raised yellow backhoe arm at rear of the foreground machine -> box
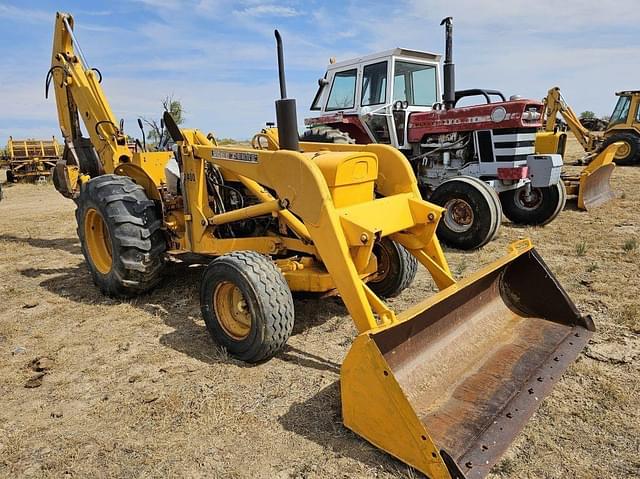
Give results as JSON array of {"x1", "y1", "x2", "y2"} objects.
[{"x1": 47, "y1": 12, "x2": 131, "y2": 173}]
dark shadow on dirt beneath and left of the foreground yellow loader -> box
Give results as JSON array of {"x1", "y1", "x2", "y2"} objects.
[{"x1": 13, "y1": 236, "x2": 347, "y2": 372}]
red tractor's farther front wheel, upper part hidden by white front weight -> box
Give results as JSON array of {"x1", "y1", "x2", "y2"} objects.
[{"x1": 500, "y1": 181, "x2": 567, "y2": 226}]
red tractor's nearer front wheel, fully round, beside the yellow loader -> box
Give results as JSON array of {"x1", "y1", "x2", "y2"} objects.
[{"x1": 429, "y1": 176, "x2": 502, "y2": 250}]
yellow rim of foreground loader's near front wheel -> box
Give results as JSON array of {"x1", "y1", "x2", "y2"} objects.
[{"x1": 218, "y1": 281, "x2": 251, "y2": 340}]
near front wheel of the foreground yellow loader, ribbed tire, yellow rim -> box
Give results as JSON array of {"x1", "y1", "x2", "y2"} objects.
[{"x1": 200, "y1": 251, "x2": 294, "y2": 363}]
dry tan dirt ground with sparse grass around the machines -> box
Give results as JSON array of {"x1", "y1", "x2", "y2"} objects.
[{"x1": 0, "y1": 137, "x2": 640, "y2": 479}]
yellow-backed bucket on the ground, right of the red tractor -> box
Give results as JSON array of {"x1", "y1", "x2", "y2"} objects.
[{"x1": 562, "y1": 143, "x2": 620, "y2": 210}]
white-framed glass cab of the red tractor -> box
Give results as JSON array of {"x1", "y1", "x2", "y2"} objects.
[{"x1": 305, "y1": 48, "x2": 442, "y2": 149}]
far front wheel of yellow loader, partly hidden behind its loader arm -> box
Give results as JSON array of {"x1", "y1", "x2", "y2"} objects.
[{"x1": 367, "y1": 238, "x2": 418, "y2": 298}]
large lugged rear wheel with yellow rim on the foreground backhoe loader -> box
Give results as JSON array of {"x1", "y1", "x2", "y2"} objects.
[{"x1": 76, "y1": 175, "x2": 166, "y2": 298}]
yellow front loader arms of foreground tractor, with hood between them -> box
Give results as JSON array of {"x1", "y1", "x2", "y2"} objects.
[{"x1": 178, "y1": 130, "x2": 455, "y2": 333}]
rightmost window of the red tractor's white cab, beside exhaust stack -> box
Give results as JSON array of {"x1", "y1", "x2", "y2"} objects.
[{"x1": 393, "y1": 61, "x2": 437, "y2": 106}]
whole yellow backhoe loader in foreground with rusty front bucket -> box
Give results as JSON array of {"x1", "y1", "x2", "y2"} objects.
[{"x1": 49, "y1": 13, "x2": 595, "y2": 479}]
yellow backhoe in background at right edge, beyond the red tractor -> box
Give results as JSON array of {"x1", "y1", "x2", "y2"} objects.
[{"x1": 536, "y1": 87, "x2": 628, "y2": 210}]
